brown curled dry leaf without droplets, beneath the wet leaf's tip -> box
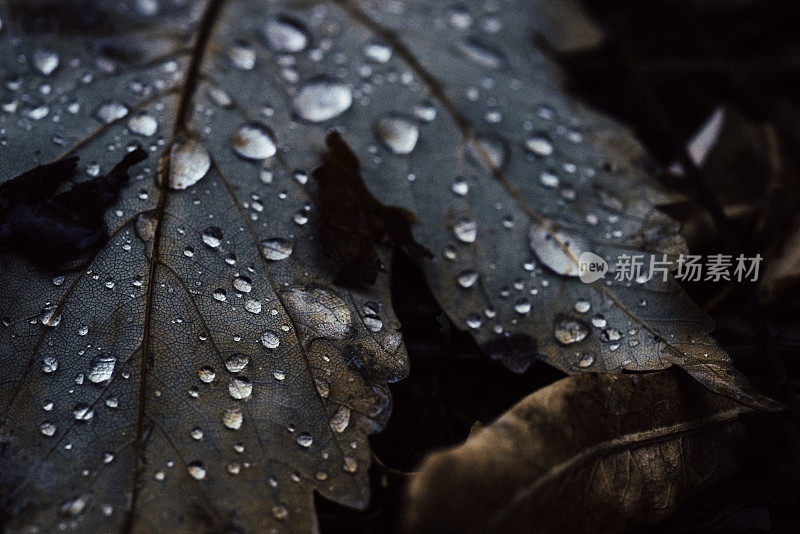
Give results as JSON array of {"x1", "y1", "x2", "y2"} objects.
[{"x1": 406, "y1": 370, "x2": 750, "y2": 533}]
